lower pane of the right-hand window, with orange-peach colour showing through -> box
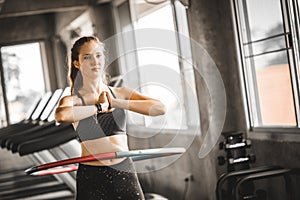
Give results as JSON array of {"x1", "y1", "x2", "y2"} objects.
[{"x1": 254, "y1": 52, "x2": 296, "y2": 126}]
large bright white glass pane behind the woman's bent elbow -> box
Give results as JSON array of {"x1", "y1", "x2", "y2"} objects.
[{"x1": 135, "y1": 2, "x2": 187, "y2": 129}]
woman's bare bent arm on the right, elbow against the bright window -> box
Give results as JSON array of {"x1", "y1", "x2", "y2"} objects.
[{"x1": 108, "y1": 87, "x2": 166, "y2": 116}]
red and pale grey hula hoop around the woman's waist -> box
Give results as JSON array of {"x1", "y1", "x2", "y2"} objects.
[{"x1": 25, "y1": 147, "x2": 185, "y2": 176}]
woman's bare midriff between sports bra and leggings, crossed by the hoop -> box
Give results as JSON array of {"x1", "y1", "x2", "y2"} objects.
[{"x1": 81, "y1": 135, "x2": 128, "y2": 166}]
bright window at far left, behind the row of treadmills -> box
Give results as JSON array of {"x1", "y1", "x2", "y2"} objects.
[{"x1": 0, "y1": 43, "x2": 45, "y2": 126}]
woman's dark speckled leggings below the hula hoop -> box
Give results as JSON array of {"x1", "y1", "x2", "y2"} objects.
[{"x1": 76, "y1": 159, "x2": 145, "y2": 200}]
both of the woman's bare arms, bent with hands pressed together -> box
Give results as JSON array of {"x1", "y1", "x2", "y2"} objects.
[{"x1": 55, "y1": 87, "x2": 166, "y2": 123}]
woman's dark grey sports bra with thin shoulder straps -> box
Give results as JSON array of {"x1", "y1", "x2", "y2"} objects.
[{"x1": 75, "y1": 87, "x2": 126, "y2": 142}]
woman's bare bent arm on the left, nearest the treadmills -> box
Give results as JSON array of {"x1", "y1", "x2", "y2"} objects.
[{"x1": 55, "y1": 96, "x2": 97, "y2": 123}]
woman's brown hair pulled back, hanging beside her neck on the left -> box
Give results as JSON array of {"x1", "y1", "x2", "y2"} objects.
[{"x1": 69, "y1": 36, "x2": 104, "y2": 93}]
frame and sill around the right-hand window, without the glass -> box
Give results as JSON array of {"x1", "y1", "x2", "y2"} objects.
[{"x1": 231, "y1": 0, "x2": 300, "y2": 141}]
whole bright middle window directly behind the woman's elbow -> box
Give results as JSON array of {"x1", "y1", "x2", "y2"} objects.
[{"x1": 115, "y1": 0, "x2": 200, "y2": 130}]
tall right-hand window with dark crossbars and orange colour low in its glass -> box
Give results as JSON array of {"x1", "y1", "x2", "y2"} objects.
[{"x1": 234, "y1": 0, "x2": 300, "y2": 128}]
